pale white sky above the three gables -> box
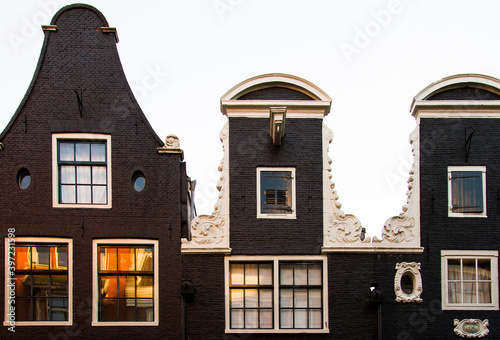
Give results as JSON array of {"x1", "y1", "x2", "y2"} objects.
[{"x1": 0, "y1": 0, "x2": 500, "y2": 236}]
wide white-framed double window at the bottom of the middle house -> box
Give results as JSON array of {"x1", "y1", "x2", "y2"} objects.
[{"x1": 225, "y1": 256, "x2": 328, "y2": 333}]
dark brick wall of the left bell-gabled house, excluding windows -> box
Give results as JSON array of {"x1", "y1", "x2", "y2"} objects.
[{"x1": 0, "y1": 6, "x2": 181, "y2": 339}]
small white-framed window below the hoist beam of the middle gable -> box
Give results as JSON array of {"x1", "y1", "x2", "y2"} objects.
[{"x1": 257, "y1": 168, "x2": 296, "y2": 218}]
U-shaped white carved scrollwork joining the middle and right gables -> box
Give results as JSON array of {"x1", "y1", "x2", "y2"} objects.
[{"x1": 322, "y1": 124, "x2": 423, "y2": 253}]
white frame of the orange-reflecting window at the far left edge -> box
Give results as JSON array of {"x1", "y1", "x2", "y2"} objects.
[{"x1": 3, "y1": 237, "x2": 73, "y2": 326}]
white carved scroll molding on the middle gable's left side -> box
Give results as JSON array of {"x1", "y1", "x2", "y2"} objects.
[{"x1": 181, "y1": 122, "x2": 231, "y2": 254}]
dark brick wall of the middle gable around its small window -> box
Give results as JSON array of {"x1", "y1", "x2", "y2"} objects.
[{"x1": 229, "y1": 118, "x2": 323, "y2": 255}]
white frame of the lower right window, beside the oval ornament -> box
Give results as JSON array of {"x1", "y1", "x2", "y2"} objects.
[{"x1": 441, "y1": 250, "x2": 498, "y2": 310}]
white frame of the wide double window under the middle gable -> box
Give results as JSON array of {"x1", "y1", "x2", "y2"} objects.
[{"x1": 224, "y1": 255, "x2": 330, "y2": 334}]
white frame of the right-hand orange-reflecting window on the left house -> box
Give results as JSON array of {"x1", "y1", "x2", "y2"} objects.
[{"x1": 92, "y1": 239, "x2": 160, "y2": 327}]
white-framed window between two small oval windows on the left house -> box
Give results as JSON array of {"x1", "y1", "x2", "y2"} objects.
[{"x1": 52, "y1": 134, "x2": 111, "y2": 208}]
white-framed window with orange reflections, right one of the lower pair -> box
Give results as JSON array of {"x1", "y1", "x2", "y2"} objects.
[{"x1": 92, "y1": 240, "x2": 159, "y2": 326}]
